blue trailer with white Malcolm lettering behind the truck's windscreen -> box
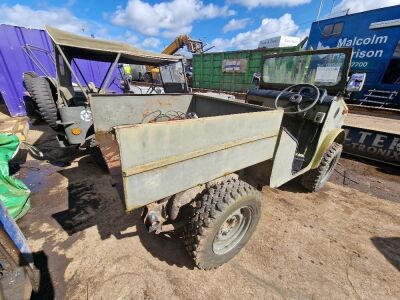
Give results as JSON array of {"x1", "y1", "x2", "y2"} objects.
[{"x1": 307, "y1": 5, "x2": 400, "y2": 105}]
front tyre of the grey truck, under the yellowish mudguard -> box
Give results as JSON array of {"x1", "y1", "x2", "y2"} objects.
[{"x1": 301, "y1": 142, "x2": 343, "y2": 192}]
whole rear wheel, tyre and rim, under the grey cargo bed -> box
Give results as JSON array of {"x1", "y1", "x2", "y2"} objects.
[{"x1": 184, "y1": 179, "x2": 261, "y2": 270}]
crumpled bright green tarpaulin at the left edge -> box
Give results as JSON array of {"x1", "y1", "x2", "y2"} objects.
[{"x1": 0, "y1": 133, "x2": 30, "y2": 220}]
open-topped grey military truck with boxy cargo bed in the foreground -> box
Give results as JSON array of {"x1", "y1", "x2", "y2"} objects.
[{"x1": 89, "y1": 48, "x2": 352, "y2": 269}]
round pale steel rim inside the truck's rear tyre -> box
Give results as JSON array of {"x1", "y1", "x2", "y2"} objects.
[{"x1": 213, "y1": 206, "x2": 253, "y2": 255}]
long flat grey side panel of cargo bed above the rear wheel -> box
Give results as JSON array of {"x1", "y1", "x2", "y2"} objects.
[{"x1": 115, "y1": 111, "x2": 282, "y2": 210}]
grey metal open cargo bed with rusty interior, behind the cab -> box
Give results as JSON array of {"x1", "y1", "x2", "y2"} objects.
[{"x1": 91, "y1": 94, "x2": 283, "y2": 210}]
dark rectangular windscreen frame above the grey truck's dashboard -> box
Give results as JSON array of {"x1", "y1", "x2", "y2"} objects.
[{"x1": 260, "y1": 48, "x2": 353, "y2": 94}]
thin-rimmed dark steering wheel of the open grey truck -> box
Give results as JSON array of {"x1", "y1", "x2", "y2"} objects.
[{"x1": 275, "y1": 83, "x2": 320, "y2": 115}]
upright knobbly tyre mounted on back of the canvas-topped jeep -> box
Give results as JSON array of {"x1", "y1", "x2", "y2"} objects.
[{"x1": 31, "y1": 77, "x2": 58, "y2": 130}]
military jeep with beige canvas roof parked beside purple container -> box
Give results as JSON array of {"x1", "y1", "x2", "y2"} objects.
[{"x1": 25, "y1": 27, "x2": 188, "y2": 147}]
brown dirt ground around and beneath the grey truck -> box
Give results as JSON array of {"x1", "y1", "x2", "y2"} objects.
[{"x1": 12, "y1": 125, "x2": 400, "y2": 299}]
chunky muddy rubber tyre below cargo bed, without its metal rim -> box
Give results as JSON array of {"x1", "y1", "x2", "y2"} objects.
[{"x1": 184, "y1": 178, "x2": 261, "y2": 270}]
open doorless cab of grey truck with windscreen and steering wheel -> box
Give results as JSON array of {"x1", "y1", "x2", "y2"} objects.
[{"x1": 246, "y1": 48, "x2": 352, "y2": 189}]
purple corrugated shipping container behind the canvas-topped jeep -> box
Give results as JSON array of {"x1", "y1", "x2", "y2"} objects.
[{"x1": 0, "y1": 24, "x2": 122, "y2": 117}]
